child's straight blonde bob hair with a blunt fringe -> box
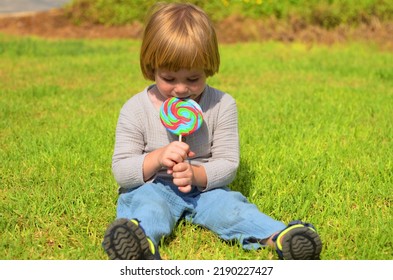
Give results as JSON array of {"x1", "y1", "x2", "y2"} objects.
[{"x1": 140, "y1": 3, "x2": 220, "y2": 81}]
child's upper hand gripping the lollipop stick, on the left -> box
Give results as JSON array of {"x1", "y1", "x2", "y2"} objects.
[{"x1": 158, "y1": 141, "x2": 195, "y2": 171}]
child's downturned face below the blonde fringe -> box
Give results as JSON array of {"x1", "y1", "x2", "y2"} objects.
[{"x1": 154, "y1": 69, "x2": 206, "y2": 100}]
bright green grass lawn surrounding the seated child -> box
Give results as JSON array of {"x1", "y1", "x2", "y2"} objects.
[{"x1": 0, "y1": 35, "x2": 393, "y2": 259}]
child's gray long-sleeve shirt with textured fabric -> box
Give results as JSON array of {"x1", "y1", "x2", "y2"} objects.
[{"x1": 112, "y1": 86, "x2": 239, "y2": 190}]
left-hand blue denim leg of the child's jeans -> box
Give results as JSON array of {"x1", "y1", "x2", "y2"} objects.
[{"x1": 117, "y1": 182, "x2": 187, "y2": 245}]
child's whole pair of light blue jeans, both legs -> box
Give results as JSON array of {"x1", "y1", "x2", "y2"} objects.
[{"x1": 117, "y1": 180, "x2": 285, "y2": 249}]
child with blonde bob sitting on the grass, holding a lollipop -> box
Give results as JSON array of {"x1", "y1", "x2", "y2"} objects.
[{"x1": 103, "y1": 4, "x2": 322, "y2": 259}]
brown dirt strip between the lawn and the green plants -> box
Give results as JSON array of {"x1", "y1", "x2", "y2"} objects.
[{"x1": 0, "y1": 9, "x2": 393, "y2": 51}]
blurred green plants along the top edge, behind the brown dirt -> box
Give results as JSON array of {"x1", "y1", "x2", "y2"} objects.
[{"x1": 68, "y1": 0, "x2": 393, "y2": 28}]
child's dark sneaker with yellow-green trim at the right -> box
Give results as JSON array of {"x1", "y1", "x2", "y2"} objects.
[{"x1": 273, "y1": 221, "x2": 322, "y2": 260}]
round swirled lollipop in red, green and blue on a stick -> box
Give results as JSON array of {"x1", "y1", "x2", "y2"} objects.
[{"x1": 160, "y1": 97, "x2": 203, "y2": 141}]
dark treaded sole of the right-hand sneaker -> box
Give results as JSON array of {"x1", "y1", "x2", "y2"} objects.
[{"x1": 282, "y1": 227, "x2": 322, "y2": 260}]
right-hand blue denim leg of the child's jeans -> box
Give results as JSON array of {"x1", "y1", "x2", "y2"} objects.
[{"x1": 192, "y1": 188, "x2": 286, "y2": 249}]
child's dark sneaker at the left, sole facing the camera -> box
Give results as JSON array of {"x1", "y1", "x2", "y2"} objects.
[{"x1": 102, "y1": 219, "x2": 161, "y2": 260}]
